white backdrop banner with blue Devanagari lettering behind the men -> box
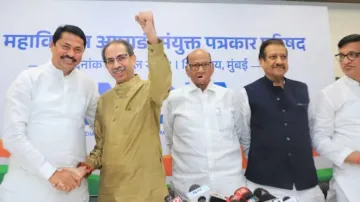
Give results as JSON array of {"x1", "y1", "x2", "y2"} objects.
[{"x1": 0, "y1": 1, "x2": 335, "y2": 188}]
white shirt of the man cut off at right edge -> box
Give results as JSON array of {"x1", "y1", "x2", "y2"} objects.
[{"x1": 312, "y1": 76, "x2": 360, "y2": 201}]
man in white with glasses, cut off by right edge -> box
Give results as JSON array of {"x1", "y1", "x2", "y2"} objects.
[{"x1": 313, "y1": 35, "x2": 360, "y2": 202}]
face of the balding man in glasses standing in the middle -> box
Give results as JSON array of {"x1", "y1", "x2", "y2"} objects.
[{"x1": 186, "y1": 49, "x2": 214, "y2": 90}]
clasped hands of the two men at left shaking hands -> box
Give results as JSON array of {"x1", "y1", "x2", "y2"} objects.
[{"x1": 49, "y1": 165, "x2": 92, "y2": 192}]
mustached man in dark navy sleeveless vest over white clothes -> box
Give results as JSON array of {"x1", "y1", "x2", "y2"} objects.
[{"x1": 241, "y1": 39, "x2": 325, "y2": 202}]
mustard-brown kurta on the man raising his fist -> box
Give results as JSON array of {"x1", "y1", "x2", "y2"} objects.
[{"x1": 87, "y1": 43, "x2": 172, "y2": 202}]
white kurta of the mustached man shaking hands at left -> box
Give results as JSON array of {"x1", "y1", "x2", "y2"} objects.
[{"x1": 0, "y1": 62, "x2": 98, "y2": 202}]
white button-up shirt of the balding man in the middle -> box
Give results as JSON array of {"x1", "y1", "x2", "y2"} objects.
[{"x1": 163, "y1": 83, "x2": 250, "y2": 196}]
